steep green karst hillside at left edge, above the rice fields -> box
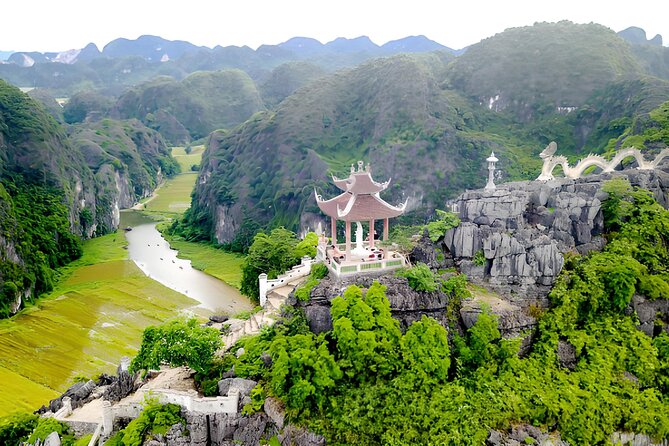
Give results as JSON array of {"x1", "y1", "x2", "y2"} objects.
[{"x1": 0, "y1": 81, "x2": 178, "y2": 317}]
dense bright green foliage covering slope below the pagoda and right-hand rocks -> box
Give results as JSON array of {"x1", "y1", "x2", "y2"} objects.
[{"x1": 196, "y1": 182, "x2": 669, "y2": 445}]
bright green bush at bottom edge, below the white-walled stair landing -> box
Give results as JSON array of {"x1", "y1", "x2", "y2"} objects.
[{"x1": 105, "y1": 400, "x2": 186, "y2": 446}]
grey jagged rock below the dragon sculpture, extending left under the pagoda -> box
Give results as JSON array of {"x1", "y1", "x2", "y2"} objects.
[{"x1": 290, "y1": 170, "x2": 669, "y2": 345}]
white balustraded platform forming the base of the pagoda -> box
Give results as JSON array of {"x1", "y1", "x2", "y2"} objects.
[{"x1": 316, "y1": 242, "x2": 406, "y2": 277}]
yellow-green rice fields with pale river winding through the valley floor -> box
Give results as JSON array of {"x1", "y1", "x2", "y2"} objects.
[{"x1": 0, "y1": 148, "x2": 251, "y2": 416}]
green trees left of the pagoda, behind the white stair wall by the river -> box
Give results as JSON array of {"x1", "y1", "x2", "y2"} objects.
[{"x1": 240, "y1": 228, "x2": 318, "y2": 301}]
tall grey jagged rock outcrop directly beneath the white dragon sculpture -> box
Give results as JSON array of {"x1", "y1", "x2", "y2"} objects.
[{"x1": 443, "y1": 170, "x2": 669, "y2": 307}]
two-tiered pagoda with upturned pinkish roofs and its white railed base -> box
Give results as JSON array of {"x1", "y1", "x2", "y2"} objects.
[{"x1": 314, "y1": 161, "x2": 406, "y2": 275}]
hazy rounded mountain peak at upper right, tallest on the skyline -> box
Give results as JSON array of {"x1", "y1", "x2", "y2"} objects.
[{"x1": 449, "y1": 21, "x2": 642, "y2": 121}]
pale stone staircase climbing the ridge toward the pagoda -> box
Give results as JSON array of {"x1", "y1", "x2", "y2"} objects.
[{"x1": 223, "y1": 277, "x2": 304, "y2": 351}]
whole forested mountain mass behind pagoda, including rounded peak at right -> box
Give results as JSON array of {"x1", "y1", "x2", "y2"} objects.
[{"x1": 179, "y1": 22, "x2": 669, "y2": 246}]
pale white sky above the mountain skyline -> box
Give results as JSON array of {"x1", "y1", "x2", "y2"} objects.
[{"x1": 0, "y1": 0, "x2": 669, "y2": 52}]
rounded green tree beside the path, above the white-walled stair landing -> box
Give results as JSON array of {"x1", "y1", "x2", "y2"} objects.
[{"x1": 130, "y1": 319, "x2": 222, "y2": 373}]
